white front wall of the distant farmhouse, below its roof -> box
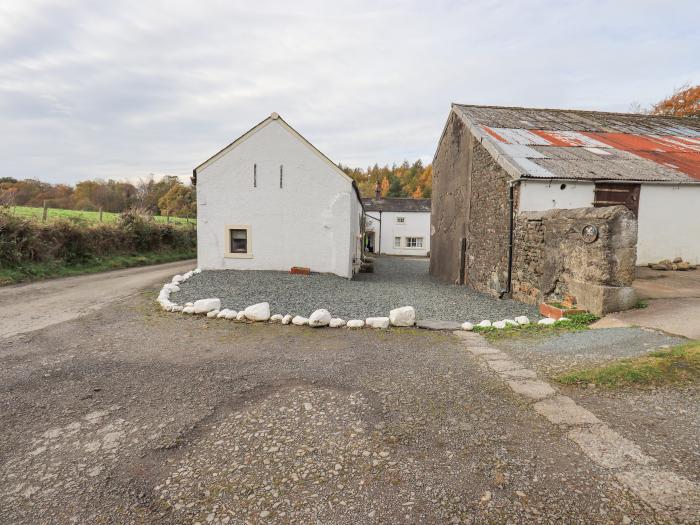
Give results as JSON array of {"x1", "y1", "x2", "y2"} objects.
[{"x1": 366, "y1": 211, "x2": 430, "y2": 257}]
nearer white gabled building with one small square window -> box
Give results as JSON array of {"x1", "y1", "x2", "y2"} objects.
[{"x1": 194, "y1": 113, "x2": 363, "y2": 278}]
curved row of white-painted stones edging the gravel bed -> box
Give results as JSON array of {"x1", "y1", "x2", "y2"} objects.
[{"x1": 158, "y1": 268, "x2": 548, "y2": 331}]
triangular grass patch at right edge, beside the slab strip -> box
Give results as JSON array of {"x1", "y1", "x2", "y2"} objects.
[{"x1": 554, "y1": 341, "x2": 700, "y2": 388}]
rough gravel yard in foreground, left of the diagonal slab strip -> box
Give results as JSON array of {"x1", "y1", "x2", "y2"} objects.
[{"x1": 0, "y1": 294, "x2": 657, "y2": 524}]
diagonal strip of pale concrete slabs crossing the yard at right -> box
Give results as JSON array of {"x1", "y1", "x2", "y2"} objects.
[{"x1": 454, "y1": 331, "x2": 700, "y2": 522}]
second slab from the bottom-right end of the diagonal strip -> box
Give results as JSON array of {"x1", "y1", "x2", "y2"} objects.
[{"x1": 568, "y1": 425, "x2": 656, "y2": 469}]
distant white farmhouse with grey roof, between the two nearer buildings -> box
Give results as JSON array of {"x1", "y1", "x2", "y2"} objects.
[{"x1": 362, "y1": 192, "x2": 430, "y2": 257}]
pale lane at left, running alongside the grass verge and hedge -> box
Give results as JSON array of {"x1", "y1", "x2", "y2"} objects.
[{"x1": 0, "y1": 259, "x2": 196, "y2": 339}]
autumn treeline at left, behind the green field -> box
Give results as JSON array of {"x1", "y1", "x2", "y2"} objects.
[{"x1": 0, "y1": 176, "x2": 197, "y2": 217}]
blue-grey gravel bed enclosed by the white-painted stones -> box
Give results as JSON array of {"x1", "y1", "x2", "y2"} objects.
[{"x1": 172, "y1": 257, "x2": 539, "y2": 322}]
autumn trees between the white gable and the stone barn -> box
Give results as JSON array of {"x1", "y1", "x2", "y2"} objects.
[{"x1": 339, "y1": 160, "x2": 433, "y2": 199}]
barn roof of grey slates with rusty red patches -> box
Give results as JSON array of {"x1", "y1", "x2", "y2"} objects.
[{"x1": 452, "y1": 104, "x2": 700, "y2": 184}]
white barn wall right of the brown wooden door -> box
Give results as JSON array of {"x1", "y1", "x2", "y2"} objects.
[{"x1": 637, "y1": 184, "x2": 700, "y2": 264}]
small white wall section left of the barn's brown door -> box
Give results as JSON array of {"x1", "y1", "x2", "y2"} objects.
[{"x1": 518, "y1": 180, "x2": 595, "y2": 211}]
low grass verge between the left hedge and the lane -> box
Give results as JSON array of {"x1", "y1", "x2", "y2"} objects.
[{"x1": 0, "y1": 250, "x2": 197, "y2": 286}]
